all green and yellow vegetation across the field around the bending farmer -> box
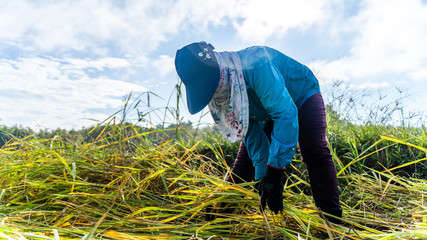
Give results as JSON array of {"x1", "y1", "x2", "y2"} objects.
[{"x1": 0, "y1": 86, "x2": 427, "y2": 240}]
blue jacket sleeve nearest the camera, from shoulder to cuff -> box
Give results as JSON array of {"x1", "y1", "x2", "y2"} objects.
[{"x1": 247, "y1": 61, "x2": 299, "y2": 176}]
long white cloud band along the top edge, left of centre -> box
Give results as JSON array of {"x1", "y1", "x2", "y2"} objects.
[{"x1": 0, "y1": 0, "x2": 237, "y2": 56}]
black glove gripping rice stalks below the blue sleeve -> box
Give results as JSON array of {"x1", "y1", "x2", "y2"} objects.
[{"x1": 258, "y1": 166, "x2": 284, "y2": 213}]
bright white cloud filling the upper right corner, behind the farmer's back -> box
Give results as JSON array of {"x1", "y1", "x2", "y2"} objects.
[{"x1": 311, "y1": 0, "x2": 427, "y2": 81}]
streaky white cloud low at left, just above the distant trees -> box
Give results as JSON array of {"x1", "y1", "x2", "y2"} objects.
[{"x1": 0, "y1": 58, "x2": 147, "y2": 128}]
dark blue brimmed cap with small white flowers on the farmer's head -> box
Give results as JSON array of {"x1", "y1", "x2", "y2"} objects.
[{"x1": 175, "y1": 42, "x2": 220, "y2": 114}]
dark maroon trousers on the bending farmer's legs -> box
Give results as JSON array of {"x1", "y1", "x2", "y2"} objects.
[{"x1": 227, "y1": 93, "x2": 342, "y2": 217}]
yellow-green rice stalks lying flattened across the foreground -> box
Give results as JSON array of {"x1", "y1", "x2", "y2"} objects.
[{"x1": 0, "y1": 118, "x2": 427, "y2": 240}]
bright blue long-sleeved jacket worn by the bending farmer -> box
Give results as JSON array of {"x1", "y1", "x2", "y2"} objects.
[{"x1": 237, "y1": 46, "x2": 320, "y2": 180}]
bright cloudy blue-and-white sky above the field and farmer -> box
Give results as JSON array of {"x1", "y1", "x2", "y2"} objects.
[{"x1": 0, "y1": 0, "x2": 427, "y2": 129}]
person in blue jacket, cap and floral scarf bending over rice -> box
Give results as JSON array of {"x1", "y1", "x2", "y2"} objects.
[{"x1": 175, "y1": 42, "x2": 342, "y2": 222}]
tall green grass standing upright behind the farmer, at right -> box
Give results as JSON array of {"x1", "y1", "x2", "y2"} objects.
[{"x1": 325, "y1": 82, "x2": 427, "y2": 179}]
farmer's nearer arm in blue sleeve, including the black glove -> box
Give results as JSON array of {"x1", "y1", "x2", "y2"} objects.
[{"x1": 252, "y1": 58, "x2": 299, "y2": 213}]
